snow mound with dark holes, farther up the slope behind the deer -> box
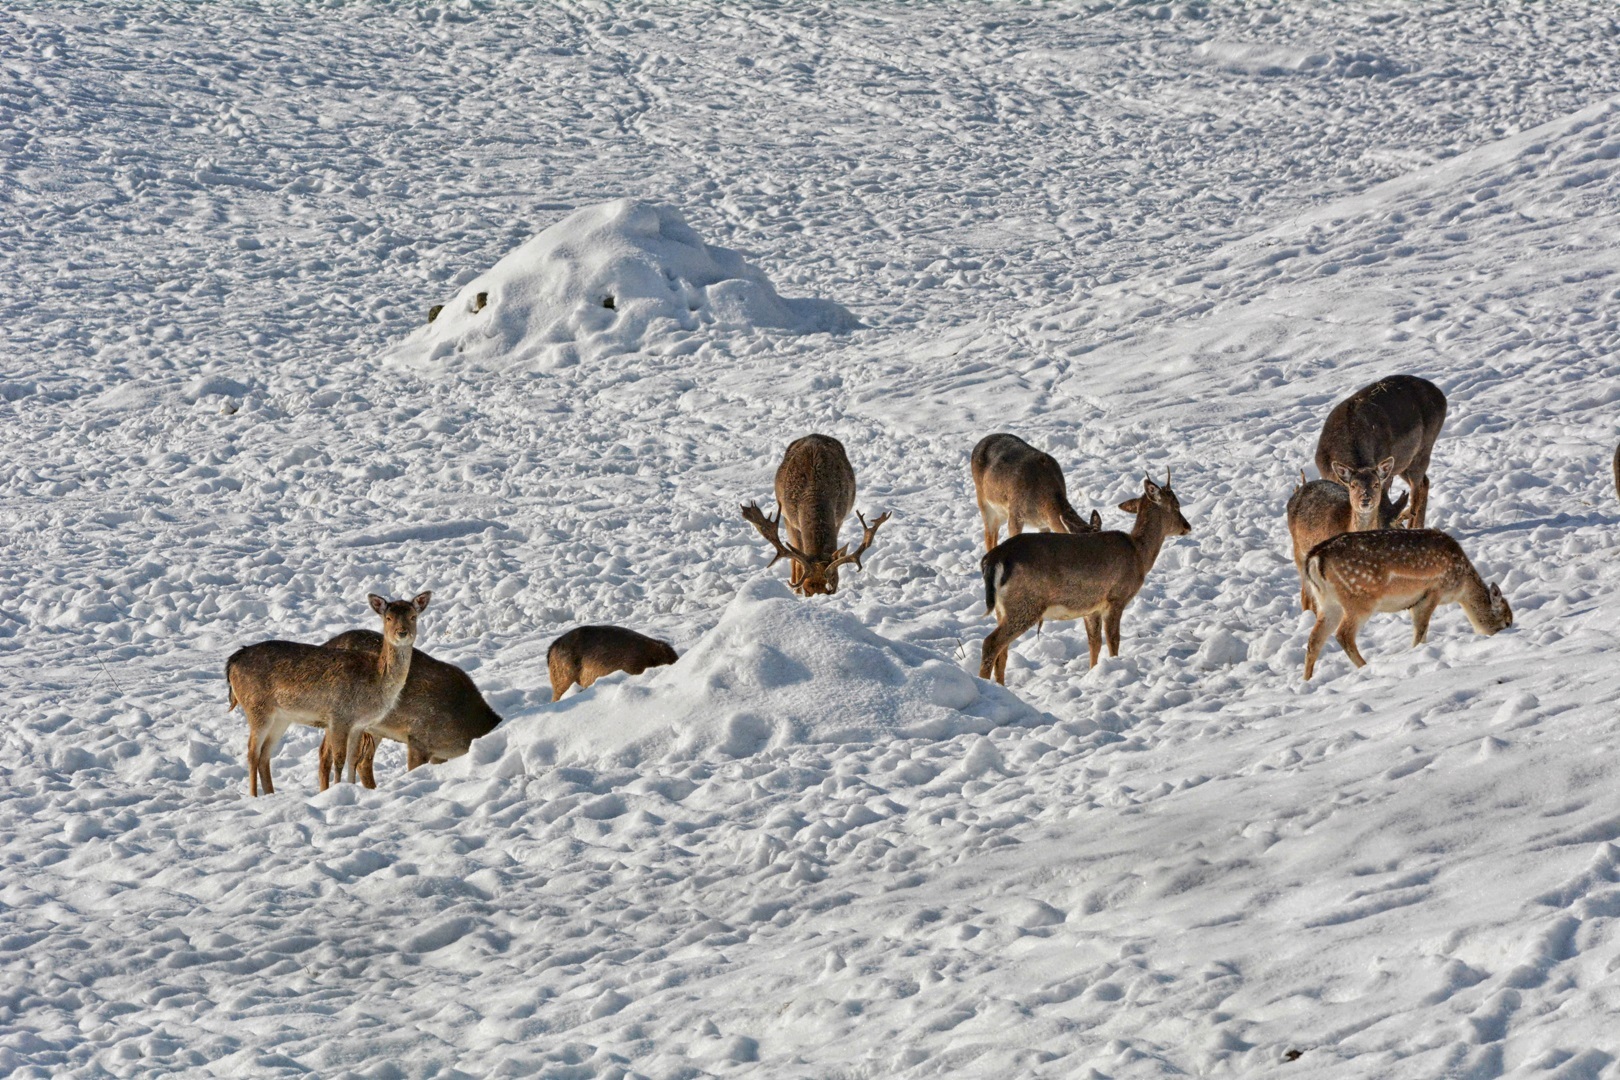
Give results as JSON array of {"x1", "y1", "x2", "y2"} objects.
[{"x1": 389, "y1": 199, "x2": 860, "y2": 368}]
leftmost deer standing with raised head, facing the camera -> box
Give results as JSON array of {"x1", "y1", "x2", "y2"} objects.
[{"x1": 225, "y1": 593, "x2": 433, "y2": 795}]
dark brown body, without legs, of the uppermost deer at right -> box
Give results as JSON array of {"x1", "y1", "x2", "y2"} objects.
[{"x1": 1315, "y1": 376, "x2": 1445, "y2": 479}]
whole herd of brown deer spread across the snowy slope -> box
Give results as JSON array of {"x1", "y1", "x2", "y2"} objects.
[{"x1": 225, "y1": 376, "x2": 1516, "y2": 795}]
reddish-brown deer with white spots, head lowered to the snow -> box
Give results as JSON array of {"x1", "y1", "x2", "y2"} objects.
[{"x1": 1306, "y1": 529, "x2": 1513, "y2": 678}]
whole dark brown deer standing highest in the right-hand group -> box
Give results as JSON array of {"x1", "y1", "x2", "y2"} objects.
[{"x1": 1317, "y1": 376, "x2": 1445, "y2": 533}]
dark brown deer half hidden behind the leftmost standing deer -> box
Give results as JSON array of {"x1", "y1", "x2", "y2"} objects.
[{"x1": 321, "y1": 630, "x2": 501, "y2": 790}]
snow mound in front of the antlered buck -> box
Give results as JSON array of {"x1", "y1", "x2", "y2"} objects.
[{"x1": 447, "y1": 578, "x2": 1053, "y2": 776}]
